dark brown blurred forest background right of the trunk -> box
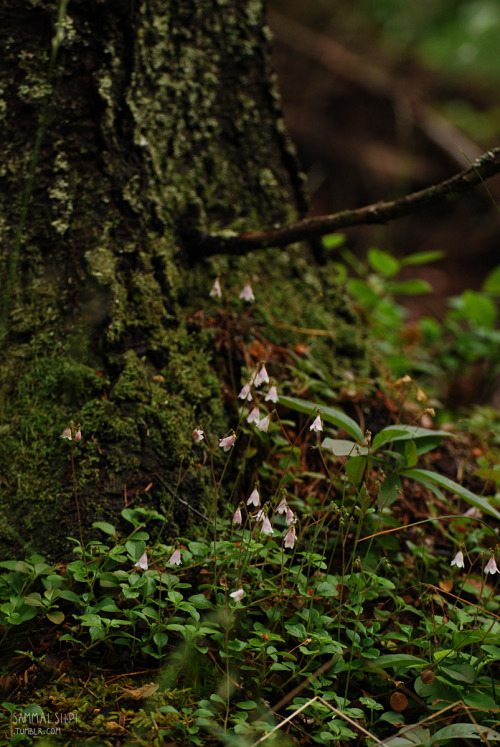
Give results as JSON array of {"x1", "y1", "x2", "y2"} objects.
[{"x1": 268, "y1": 0, "x2": 500, "y2": 315}]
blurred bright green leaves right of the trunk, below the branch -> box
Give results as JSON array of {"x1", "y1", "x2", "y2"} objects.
[{"x1": 330, "y1": 238, "x2": 500, "y2": 404}]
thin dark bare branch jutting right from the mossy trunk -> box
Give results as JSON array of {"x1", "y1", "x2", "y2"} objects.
[{"x1": 184, "y1": 148, "x2": 500, "y2": 259}]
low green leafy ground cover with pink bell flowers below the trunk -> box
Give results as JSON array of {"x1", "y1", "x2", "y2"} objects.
[{"x1": 0, "y1": 386, "x2": 500, "y2": 745}]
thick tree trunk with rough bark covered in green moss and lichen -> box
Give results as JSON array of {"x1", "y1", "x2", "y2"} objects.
[{"x1": 0, "y1": 0, "x2": 367, "y2": 557}]
